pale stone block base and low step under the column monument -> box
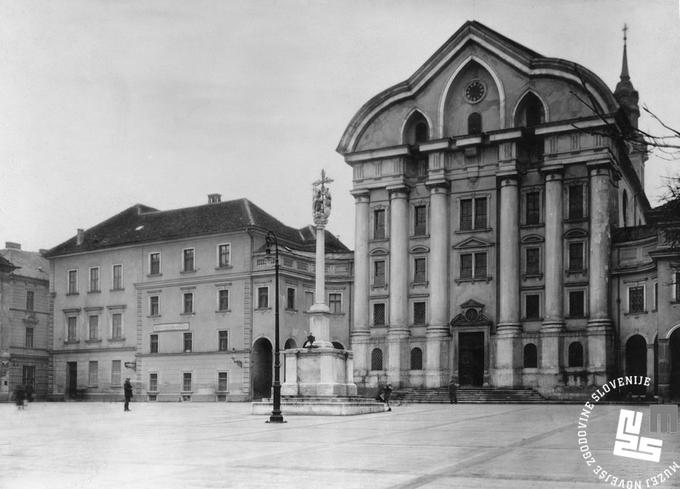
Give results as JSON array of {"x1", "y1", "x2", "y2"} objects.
[{"x1": 252, "y1": 347, "x2": 385, "y2": 416}]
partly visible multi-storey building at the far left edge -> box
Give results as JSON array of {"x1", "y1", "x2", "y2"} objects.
[{"x1": 0, "y1": 242, "x2": 50, "y2": 400}]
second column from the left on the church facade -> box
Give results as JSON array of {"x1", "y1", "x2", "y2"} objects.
[{"x1": 387, "y1": 187, "x2": 410, "y2": 387}]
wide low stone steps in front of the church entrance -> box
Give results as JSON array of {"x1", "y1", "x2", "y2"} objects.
[{"x1": 392, "y1": 387, "x2": 546, "y2": 404}]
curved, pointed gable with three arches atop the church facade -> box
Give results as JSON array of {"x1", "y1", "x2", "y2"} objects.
[{"x1": 337, "y1": 21, "x2": 617, "y2": 154}]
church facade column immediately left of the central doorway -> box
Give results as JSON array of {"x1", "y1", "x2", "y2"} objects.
[{"x1": 425, "y1": 182, "x2": 449, "y2": 387}]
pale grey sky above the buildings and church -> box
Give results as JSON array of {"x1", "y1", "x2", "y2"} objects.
[{"x1": 0, "y1": 0, "x2": 680, "y2": 250}]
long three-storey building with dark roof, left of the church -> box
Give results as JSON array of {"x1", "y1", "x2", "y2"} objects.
[{"x1": 46, "y1": 194, "x2": 352, "y2": 401}]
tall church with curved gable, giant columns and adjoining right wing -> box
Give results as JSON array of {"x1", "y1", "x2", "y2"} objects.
[{"x1": 337, "y1": 21, "x2": 680, "y2": 399}]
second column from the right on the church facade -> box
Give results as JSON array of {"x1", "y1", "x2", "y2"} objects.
[{"x1": 539, "y1": 168, "x2": 564, "y2": 390}]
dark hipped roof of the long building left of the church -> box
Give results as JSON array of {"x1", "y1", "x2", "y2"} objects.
[{"x1": 45, "y1": 199, "x2": 350, "y2": 258}]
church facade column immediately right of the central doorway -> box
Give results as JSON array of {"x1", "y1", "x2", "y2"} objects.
[{"x1": 494, "y1": 175, "x2": 521, "y2": 386}]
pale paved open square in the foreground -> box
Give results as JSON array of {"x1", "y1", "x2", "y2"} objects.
[{"x1": 0, "y1": 402, "x2": 680, "y2": 489}]
